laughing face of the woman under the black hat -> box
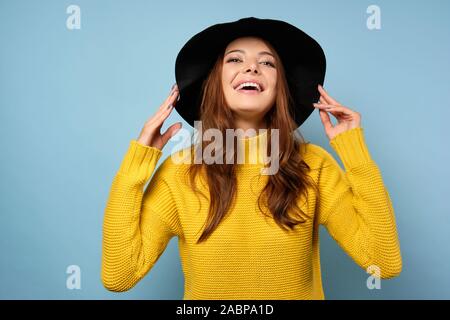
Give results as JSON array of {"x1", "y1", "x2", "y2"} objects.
[{"x1": 222, "y1": 37, "x2": 277, "y2": 124}]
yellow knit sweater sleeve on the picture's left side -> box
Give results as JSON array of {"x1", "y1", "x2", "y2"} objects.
[{"x1": 101, "y1": 140, "x2": 179, "y2": 292}]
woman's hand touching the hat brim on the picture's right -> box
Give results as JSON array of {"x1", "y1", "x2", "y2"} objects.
[{"x1": 313, "y1": 84, "x2": 361, "y2": 140}]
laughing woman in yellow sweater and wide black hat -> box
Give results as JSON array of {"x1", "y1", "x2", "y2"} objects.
[{"x1": 102, "y1": 18, "x2": 402, "y2": 299}]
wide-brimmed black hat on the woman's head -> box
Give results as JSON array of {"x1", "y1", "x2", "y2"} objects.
[{"x1": 175, "y1": 17, "x2": 326, "y2": 126}]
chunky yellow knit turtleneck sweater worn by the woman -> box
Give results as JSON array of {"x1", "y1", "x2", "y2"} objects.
[{"x1": 101, "y1": 128, "x2": 402, "y2": 300}]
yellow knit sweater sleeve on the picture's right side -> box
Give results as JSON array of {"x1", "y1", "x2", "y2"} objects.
[{"x1": 318, "y1": 127, "x2": 402, "y2": 279}]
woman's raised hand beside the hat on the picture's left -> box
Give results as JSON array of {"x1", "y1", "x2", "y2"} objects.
[{"x1": 137, "y1": 84, "x2": 181, "y2": 150}]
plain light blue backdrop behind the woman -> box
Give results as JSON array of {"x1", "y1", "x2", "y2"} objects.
[{"x1": 0, "y1": 0, "x2": 450, "y2": 299}]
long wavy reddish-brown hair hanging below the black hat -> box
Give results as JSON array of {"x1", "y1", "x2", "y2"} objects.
[{"x1": 189, "y1": 39, "x2": 318, "y2": 243}]
